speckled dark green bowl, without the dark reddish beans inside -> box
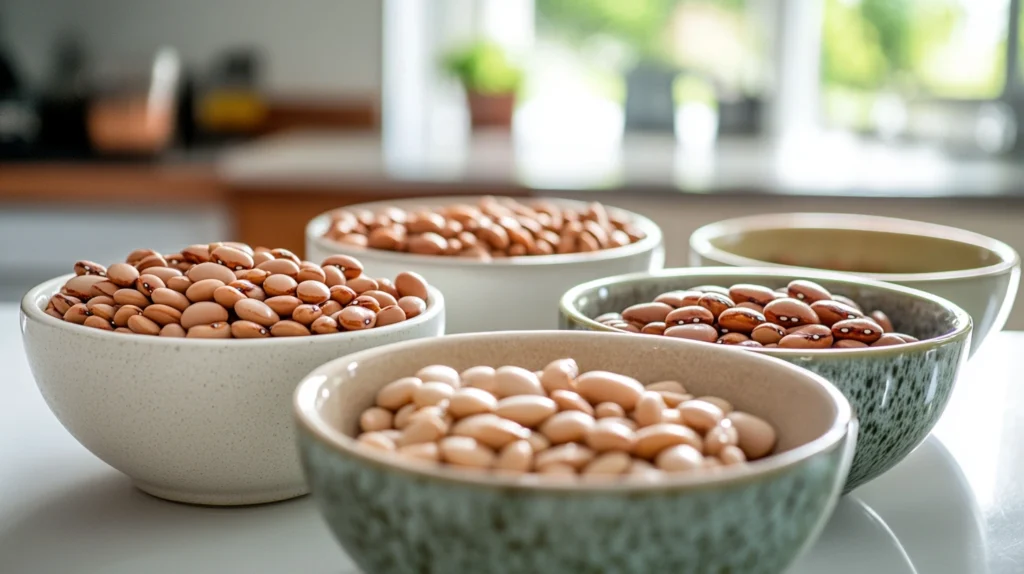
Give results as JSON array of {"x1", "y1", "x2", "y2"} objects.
[{"x1": 561, "y1": 267, "x2": 971, "y2": 492}]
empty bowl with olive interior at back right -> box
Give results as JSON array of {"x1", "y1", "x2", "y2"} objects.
[{"x1": 690, "y1": 213, "x2": 1020, "y2": 355}]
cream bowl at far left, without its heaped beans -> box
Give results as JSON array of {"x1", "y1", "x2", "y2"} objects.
[{"x1": 20, "y1": 275, "x2": 444, "y2": 505}]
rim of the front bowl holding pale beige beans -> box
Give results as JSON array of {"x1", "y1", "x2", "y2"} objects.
[{"x1": 292, "y1": 330, "x2": 858, "y2": 494}]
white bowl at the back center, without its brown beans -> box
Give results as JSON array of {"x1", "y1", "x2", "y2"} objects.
[{"x1": 306, "y1": 196, "x2": 665, "y2": 334}]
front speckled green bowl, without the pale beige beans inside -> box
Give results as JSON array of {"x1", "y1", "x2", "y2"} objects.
[{"x1": 295, "y1": 332, "x2": 856, "y2": 574}]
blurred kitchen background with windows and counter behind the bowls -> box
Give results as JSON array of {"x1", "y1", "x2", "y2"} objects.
[{"x1": 0, "y1": 0, "x2": 1024, "y2": 328}]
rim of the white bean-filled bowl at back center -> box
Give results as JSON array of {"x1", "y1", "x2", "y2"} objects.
[{"x1": 305, "y1": 194, "x2": 663, "y2": 268}]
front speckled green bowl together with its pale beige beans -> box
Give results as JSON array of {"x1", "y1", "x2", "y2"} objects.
[{"x1": 294, "y1": 332, "x2": 857, "y2": 574}]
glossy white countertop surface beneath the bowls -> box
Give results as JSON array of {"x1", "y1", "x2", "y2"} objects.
[{"x1": 0, "y1": 305, "x2": 1024, "y2": 574}]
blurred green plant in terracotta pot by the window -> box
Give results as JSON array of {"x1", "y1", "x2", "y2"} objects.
[{"x1": 444, "y1": 41, "x2": 522, "y2": 128}]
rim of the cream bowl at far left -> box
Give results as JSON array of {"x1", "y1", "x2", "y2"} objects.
[{"x1": 20, "y1": 273, "x2": 444, "y2": 349}]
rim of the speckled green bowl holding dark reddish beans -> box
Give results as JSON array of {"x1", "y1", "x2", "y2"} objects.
[{"x1": 558, "y1": 267, "x2": 974, "y2": 359}]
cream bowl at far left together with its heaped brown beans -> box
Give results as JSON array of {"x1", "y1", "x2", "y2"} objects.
[{"x1": 22, "y1": 242, "x2": 444, "y2": 505}]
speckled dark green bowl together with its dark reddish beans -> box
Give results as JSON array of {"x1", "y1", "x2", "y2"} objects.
[{"x1": 561, "y1": 267, "x2": 972, "y2": 491}]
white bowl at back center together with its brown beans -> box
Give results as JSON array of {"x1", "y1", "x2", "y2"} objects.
[{"x1": 306, "y1": 196, "x2": 665, "y2": 334}]
